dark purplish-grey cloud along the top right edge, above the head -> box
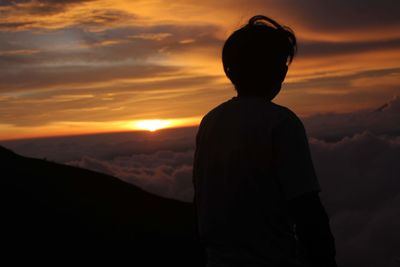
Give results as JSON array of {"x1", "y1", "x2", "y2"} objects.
[{"x1": 203, "y1": 0, "x2": 400, "y2": 32}]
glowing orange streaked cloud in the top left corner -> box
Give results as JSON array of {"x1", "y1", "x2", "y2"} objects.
[{"x1": 0, "y1": 0, "x2": 137, "y2": 32}]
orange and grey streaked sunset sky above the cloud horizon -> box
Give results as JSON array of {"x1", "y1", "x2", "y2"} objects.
[{"x1": 0, "y1": 0, "x2": 400, "y2": 140}]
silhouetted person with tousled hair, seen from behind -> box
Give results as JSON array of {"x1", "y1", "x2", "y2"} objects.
[{"x1": 193, "y1": 16, "x2": 336, "y2": 267}]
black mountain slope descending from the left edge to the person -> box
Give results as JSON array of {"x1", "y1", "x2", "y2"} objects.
[{"x1": 0, "y1": 147, "x2": 203, "y2": 266}]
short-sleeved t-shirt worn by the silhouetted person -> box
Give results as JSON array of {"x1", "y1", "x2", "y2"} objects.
[{"x1": 193, "y1": 97, "x2": 320, "y2": 266}]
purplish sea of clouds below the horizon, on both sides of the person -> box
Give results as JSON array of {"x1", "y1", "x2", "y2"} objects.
[{"x1": 1, "y1": 97, "x2": 400, "y2": 267}]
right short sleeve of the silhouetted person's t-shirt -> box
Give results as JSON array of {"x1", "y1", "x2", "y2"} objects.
[{"x1": 273, "y1": 112, "x2": 321, "y2": 200}]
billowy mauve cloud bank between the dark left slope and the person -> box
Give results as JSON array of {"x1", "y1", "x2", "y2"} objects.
[{"x1": 68, "y1": 150, "x2": 193, "y2": 202}]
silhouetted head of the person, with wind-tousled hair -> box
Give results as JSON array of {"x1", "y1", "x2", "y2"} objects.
[{"x1": 222, "y1": 15, "x2": 297, "y2": 100}]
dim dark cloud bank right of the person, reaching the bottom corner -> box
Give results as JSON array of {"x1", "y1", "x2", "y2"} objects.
[{"x1": 310, "y1": 132, "x2": 400, "y2": 267}]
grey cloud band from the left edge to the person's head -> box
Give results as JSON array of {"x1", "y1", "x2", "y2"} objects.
[{"x1": 0, "y1": 22, "x2": 222, "y2": 68}]
